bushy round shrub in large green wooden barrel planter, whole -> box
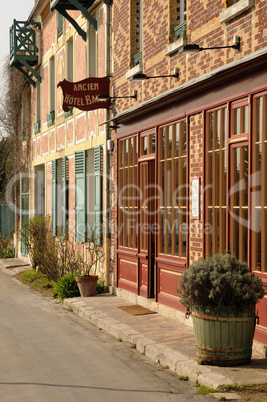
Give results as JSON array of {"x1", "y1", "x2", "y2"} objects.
[{"x1": 177, "y1": 254, "x2": 264, "y2": 366}]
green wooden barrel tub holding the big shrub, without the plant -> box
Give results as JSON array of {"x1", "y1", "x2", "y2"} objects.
[{"x1": 192, "y1": 305, "x2": 256, "y2": 367}]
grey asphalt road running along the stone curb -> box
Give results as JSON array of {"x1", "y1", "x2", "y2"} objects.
[{"x1": 0, "y1": 270, "x2": 211, "y2": 402}]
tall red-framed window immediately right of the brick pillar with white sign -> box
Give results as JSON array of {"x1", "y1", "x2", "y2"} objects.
[{"x1": 205, "y1": 107, "x2": 227, "y2": 255}]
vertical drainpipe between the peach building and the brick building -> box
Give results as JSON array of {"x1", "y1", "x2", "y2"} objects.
[{"x1": 103, "y1": 0, "x2": 112, "y2": 286}]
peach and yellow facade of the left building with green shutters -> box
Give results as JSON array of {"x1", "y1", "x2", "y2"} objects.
[{"x1": 10, "y1": 0, "x2": 109, "y2": 280}]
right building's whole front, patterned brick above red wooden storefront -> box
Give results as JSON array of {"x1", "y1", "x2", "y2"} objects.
[{"x1": 112, "y1": 0, "x2": 267, "y2": 344}]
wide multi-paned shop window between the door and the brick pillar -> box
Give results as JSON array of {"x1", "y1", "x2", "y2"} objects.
[{"x1": 158, "y1": 120, "x2": 187, "y2": 258}]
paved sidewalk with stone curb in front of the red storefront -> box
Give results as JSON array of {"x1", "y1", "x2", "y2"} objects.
[{"x1": 0, "y1": 259, "x2": 267, "y2": 389}]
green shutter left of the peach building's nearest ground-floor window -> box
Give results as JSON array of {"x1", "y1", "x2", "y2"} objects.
[{"x1": 75, "y1": 150, "x2": 86, "y2": 242}]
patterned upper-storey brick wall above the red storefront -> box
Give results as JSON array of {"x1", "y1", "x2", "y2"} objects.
[{"x1": 113, "y1": 0, "x2": 267, "y2": 113}]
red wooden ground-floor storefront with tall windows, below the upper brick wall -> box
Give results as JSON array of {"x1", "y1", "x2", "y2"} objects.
[{"x1": 115, "y1": 53, "x2": 267, "y2": 344}]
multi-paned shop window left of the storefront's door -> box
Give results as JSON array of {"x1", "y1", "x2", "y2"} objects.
[{"x1": 118, "y1": 136, "x2": 138, "y2": 249}]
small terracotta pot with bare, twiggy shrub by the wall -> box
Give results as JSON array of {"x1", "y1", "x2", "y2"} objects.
[{"x1": 76, "y1": 232, "x2": 105, "y2": 297}]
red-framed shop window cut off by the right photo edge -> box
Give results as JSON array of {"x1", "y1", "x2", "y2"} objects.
[{"x1": 252, "y1": 94, "x2": 267, "y2": 272}]
